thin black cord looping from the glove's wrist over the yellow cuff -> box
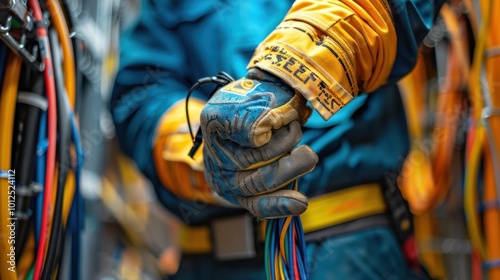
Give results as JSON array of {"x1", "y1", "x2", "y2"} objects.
[{"x1": 186, "y1": 72, "x2": 234, "y2": 158}]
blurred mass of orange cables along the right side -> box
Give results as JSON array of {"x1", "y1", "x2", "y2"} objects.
[{"x1": 394, "y1": 0, "x2": 500, "y2": 279}]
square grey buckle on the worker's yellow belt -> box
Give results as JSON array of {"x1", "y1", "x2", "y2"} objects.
[{"x1": 211, "y1": 214, "x2": 257, "y2": 261}]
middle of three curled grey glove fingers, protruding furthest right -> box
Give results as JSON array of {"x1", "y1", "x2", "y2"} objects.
[{"x1": 234, "y1": 145, "x2": 318, "y2": 196}]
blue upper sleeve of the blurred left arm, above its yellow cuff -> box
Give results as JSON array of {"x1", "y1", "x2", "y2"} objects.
[{"x1": 111, "y1": 1, "x2": 188, "y2": 170}]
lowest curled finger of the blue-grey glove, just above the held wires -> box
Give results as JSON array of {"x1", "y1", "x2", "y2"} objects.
[{"x1": 238, "y1": 189, "x2": 307, "y2": 219}]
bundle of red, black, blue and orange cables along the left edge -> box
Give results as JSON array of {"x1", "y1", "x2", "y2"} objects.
[{"x1": 0, "y1": 0, "x2": 83, "y2": 280}]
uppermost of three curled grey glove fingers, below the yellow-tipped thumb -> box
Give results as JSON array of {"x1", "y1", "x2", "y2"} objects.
[{"x1": 214, "y1": 121, "x2": 302, "y2": 168}]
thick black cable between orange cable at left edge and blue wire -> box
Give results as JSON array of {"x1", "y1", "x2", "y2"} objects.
[{"x1": 12, "y1": 64, "x2": 45, "y2": 261}]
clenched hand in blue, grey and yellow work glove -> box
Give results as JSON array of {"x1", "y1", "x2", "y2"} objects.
[{"x1": 201, "y1": 69, "x2": 318, "y2": 218}]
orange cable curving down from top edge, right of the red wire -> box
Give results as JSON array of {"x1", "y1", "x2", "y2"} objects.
[{"x1": 47, "y1": 0, "x2": 76, "y2": 108}]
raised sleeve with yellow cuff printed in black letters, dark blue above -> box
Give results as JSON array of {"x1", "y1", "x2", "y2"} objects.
[{"x1": 248, "y1": 0, "x2": 443, "y2": 119}]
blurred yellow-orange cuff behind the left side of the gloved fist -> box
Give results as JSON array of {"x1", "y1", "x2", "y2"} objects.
[{"x1": 153, "y1": 99, "x2": 216, "y2": 204}]
